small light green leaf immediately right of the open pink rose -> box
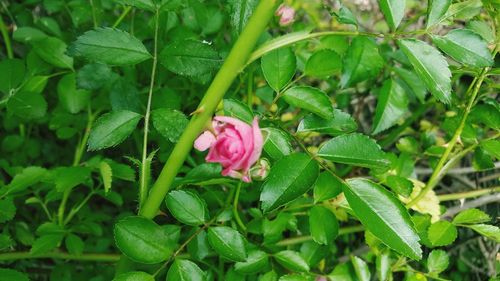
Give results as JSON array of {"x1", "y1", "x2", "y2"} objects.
[{"x1": 262, "y1": 127, "x2": 293, "y2": 160}]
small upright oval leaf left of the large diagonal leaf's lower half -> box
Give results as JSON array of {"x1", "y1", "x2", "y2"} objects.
[{"x1": 309, "y1": 206, "x2": 339, "y2": 245}]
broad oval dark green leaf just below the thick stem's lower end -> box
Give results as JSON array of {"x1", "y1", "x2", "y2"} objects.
[{"x1": 114, "y1": 216, "x2": 173, "y2": 264}]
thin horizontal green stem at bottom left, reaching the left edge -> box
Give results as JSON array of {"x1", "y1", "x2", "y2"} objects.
[{"x1": 0, "y1": 252, "x2": 120, "y2": 262}]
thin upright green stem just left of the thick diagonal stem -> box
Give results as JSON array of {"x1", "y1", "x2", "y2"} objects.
[{"x1": 139, "y1": 10, "x2": 160, "y2": 209}]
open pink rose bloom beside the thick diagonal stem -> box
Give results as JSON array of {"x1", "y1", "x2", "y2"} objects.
[{"x1": 194, "y1": 116, "x2": 264, "y2": 182}]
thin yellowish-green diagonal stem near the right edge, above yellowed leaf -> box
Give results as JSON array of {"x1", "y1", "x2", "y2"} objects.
[{"x1": 406, "y1": 68, "x2": 489, "y2": 208}]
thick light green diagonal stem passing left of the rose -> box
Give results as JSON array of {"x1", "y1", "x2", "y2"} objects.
[{"x1": 140, "y1": 0, "x2": 280, "y2": 218}]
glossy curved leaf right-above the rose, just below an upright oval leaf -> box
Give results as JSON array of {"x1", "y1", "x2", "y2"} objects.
[{"x1": 282, "y1": 86, "x2": 333, "y2": 119}]
